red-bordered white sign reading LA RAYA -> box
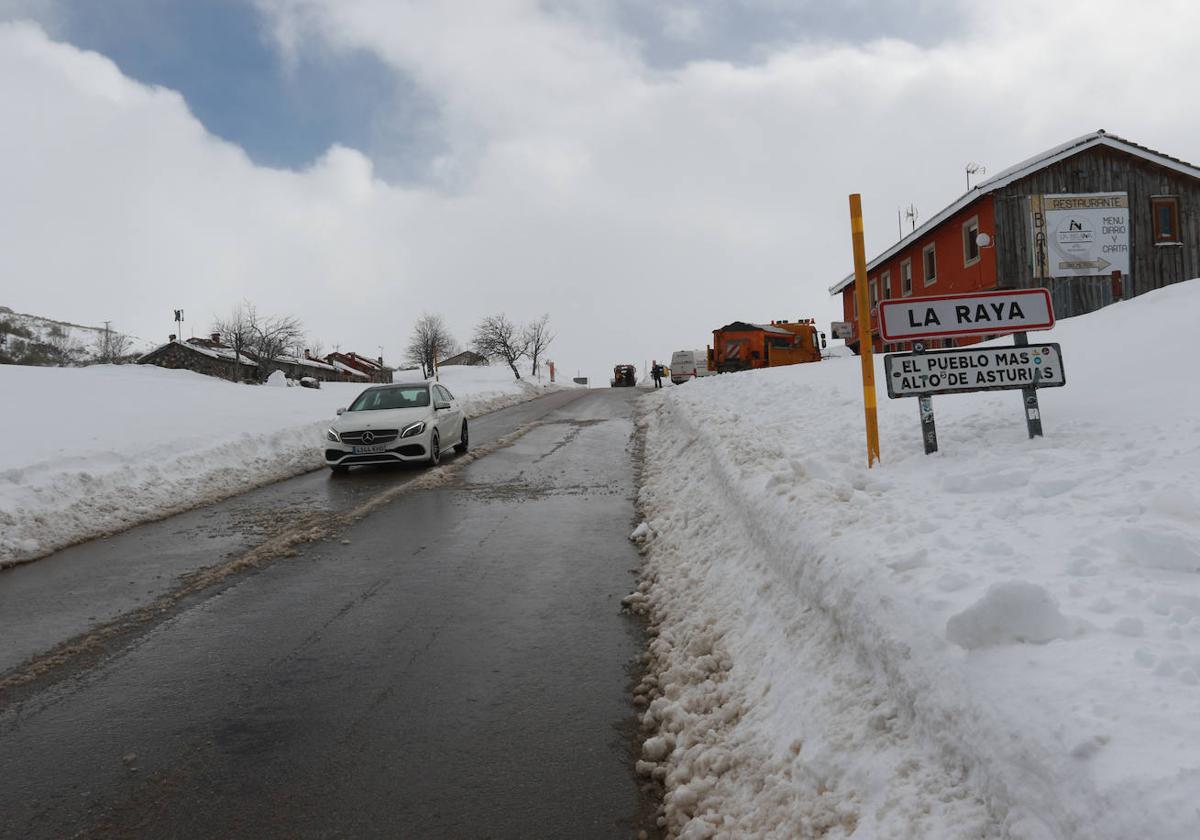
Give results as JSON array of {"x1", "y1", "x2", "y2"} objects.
[{"x1": 880, "y1": 289, "x2": 1054, "y2": 342}]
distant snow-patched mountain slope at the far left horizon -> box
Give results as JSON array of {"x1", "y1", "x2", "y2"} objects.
[{"x1": 0, "y1": 306, "x2": 156, "y2": 365}]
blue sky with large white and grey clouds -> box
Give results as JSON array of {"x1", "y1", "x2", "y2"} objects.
[{"x1": 0, "y1": 0, "x2": 1200, "y2": 380}]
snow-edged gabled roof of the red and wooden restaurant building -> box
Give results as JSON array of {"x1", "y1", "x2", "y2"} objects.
[{"x1": 829, "y1": 128, "x2": 1200, "y2": 295}]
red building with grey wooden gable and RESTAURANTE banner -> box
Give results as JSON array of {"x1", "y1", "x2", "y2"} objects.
[{"x1": 829, "y1": 131, "x2": 1200, "y2": 352}]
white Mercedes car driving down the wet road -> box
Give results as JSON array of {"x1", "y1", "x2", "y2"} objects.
[{"x1": 325, "y1": 382, "x2": 468, "y2": 473}]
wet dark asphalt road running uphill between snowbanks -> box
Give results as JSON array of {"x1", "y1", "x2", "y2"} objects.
[{"x1": 0, "y1": 390, "x2": 647, "y2": 838}]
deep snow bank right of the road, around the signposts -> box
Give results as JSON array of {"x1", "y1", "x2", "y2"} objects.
[{"x1": 629, "y1": 281, "x2": 1200, "y2": 840}]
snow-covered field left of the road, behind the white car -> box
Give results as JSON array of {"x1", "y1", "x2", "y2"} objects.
[{"x1": 0, "y1": 365, "x2": 566, "y2": 565}]
